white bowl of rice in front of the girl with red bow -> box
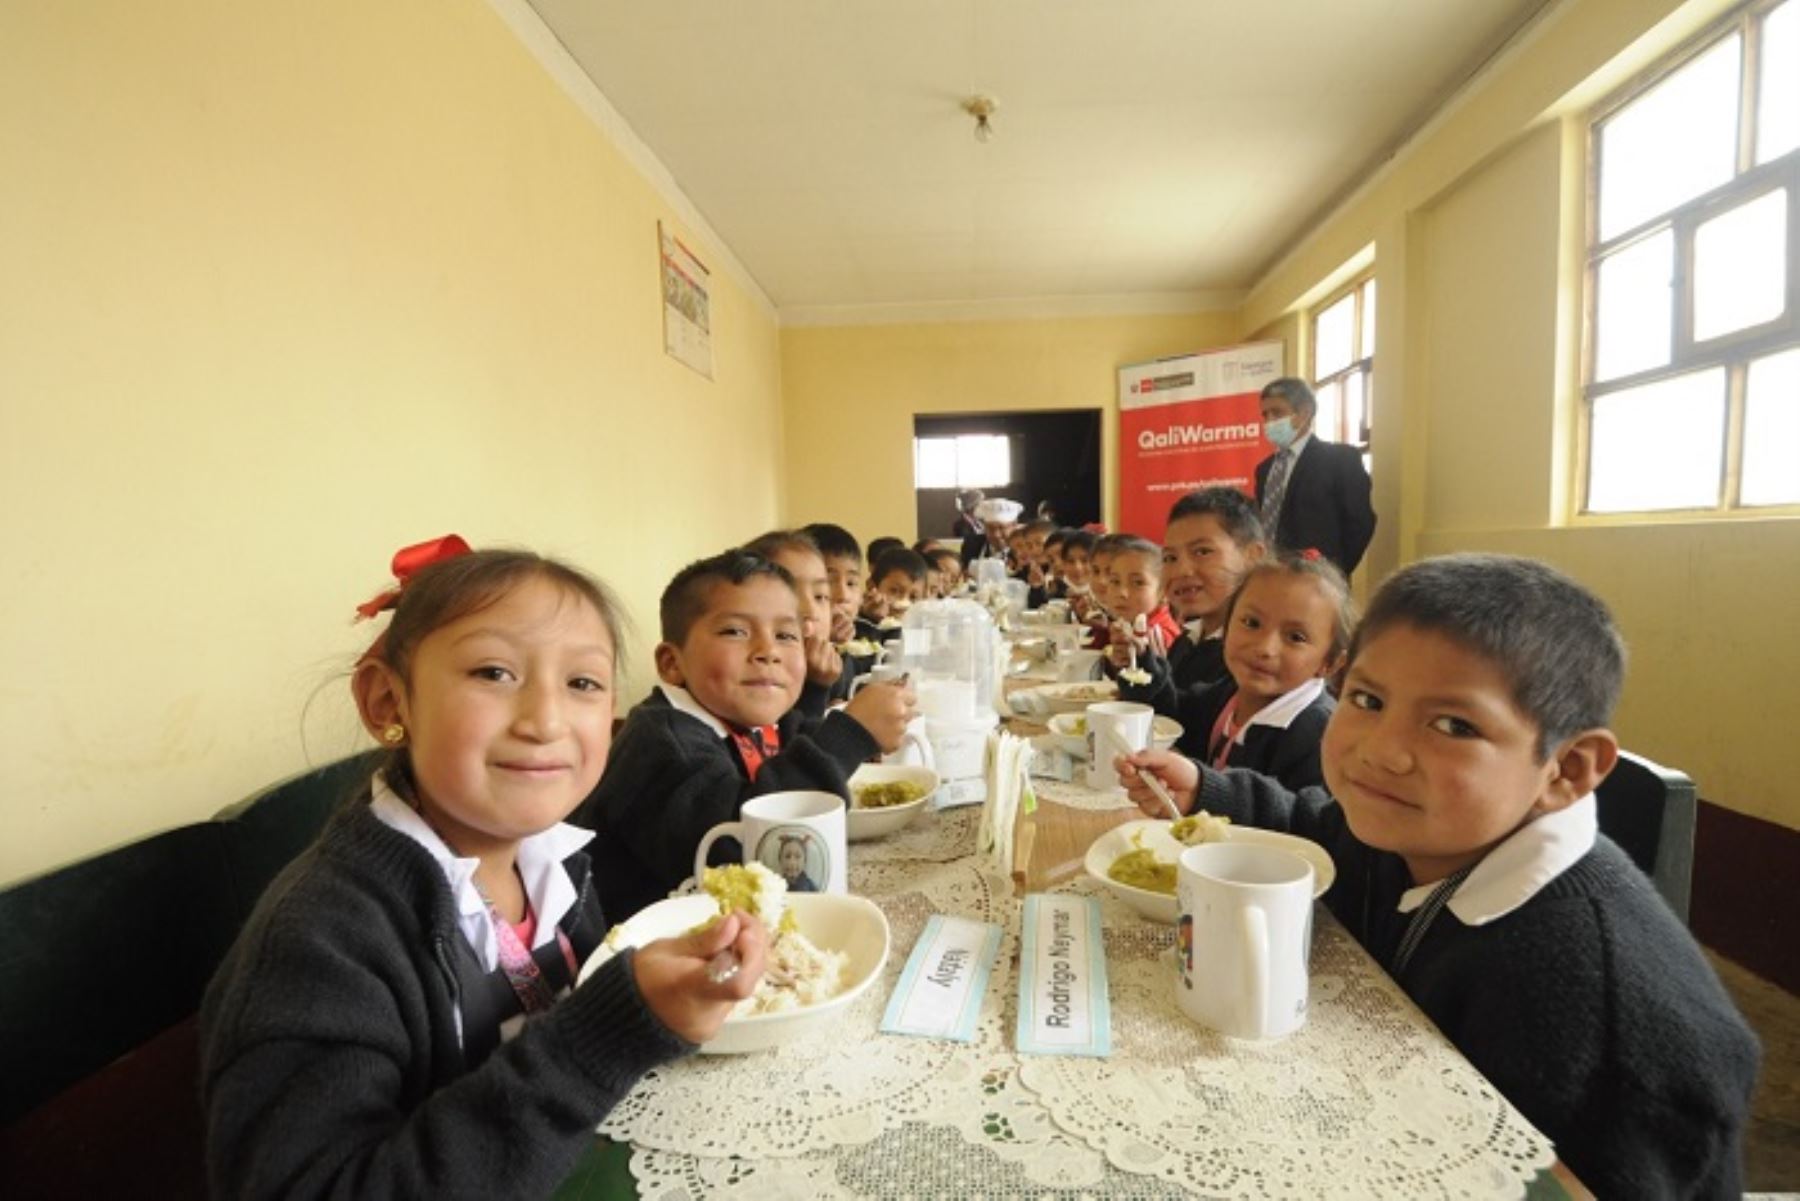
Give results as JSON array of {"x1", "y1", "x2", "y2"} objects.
[{"x1": 580, "y1": 875, "x2": 887, "y2": 1055}]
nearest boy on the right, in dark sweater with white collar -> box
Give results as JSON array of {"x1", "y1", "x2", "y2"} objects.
[{"x1": 1120, "y1": 555, "x2": 1759, "y2": 1197}]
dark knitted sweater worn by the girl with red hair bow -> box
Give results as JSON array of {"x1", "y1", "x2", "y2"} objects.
[{"x1": 200, "y1": 803, "x2": 693, "y2": 1199}]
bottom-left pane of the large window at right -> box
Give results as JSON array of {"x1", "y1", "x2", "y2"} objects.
[{"x1": 1588, "y1": 367, "x2": 1724, "y2": 513}]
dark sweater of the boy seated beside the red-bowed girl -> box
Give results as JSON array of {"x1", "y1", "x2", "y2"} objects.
[{"x1": 569, "y1": 690, "x2": 880, "y2": 922}]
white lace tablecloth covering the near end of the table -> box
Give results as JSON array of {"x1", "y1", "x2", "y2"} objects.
[{"x1": 601, "y1": 853, "x2": 1555, "y2": 1201}]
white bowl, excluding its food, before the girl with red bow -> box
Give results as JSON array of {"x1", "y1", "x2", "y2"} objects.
[{"x1": 578, "y1": 893, "x2": 887, "y2": 1055}]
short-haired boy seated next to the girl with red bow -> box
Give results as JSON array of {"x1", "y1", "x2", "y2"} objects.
[{"x1": 572, "y1": 551, "x2": 914, "y2": 924}]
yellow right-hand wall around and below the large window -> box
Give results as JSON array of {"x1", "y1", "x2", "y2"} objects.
[{"x1": 1240, "y1": 0, "x2": 1800, "y2": 826}]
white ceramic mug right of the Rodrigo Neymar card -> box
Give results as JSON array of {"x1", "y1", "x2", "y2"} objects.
[{"x1": 1175, "y1": 843, "x2": 1312, "y2": 1039}]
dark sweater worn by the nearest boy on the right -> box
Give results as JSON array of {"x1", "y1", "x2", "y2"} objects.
[{"x1": 1197, "y1": 769, "x2": 1760, "y2": 1197}]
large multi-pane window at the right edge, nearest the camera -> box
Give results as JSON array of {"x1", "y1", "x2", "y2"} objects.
[{"x1": 1582, "y1": 0, "x2": 1800, "y2": 513}]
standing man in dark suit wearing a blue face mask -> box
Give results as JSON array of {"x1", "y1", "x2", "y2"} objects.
[{"x1": 1256, "y1": 378, "x2": 1375, "y2": 576}]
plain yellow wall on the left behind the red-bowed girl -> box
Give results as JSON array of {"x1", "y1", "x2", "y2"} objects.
[{"x1": 0, "y1": 0, "x2": 783, "y2": 880}]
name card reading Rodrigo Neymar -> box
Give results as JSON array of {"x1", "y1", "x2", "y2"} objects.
[{"x1": 1019, "y1": 893, "x2": 1112, "y2": 1055}]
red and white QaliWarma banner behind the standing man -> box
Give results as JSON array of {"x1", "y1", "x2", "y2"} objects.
[{"x1": 1120, "y1": 342, "x2": 1282, "y2": 542}]
